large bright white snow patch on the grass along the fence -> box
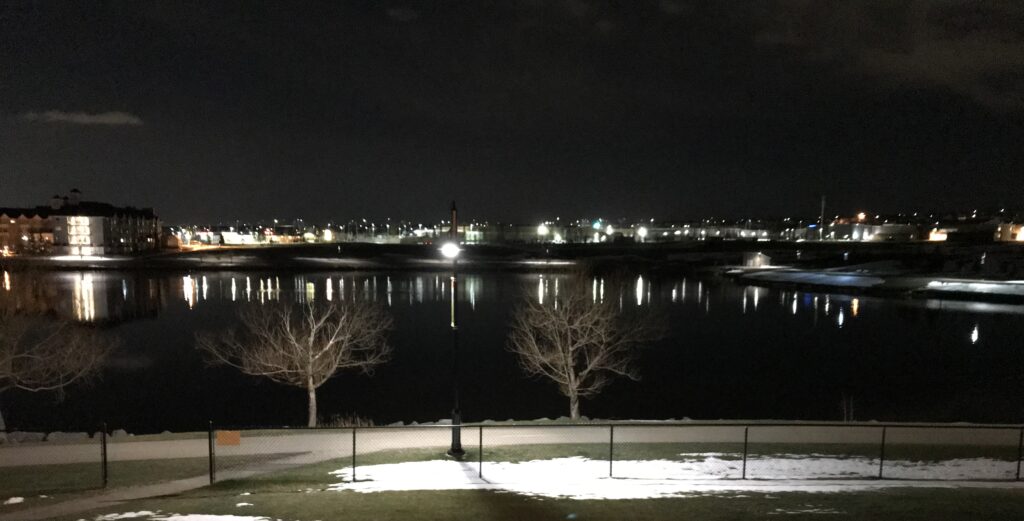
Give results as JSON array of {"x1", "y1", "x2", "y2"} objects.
[{"x1": 328, "y1": 457, "x2": 1024, "y2": 500}]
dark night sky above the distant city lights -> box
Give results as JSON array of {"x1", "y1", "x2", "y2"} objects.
[{"x1": 0, "y1": 0, "x2": 1024, "y2": 223}]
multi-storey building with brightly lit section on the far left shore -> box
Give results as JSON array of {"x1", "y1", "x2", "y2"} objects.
[{"x1": 0, "y1": 189, "x2": 160, "y2": 255}]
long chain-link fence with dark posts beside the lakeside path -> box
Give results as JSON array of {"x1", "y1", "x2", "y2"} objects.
[{"x1": 0, "y1": 422, "x2": 1024, "y2": 500}]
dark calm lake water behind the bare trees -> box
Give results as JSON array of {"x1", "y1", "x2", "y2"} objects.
[{"x1": 0, "y1": 272, "x2": 1024, "y2": 433}]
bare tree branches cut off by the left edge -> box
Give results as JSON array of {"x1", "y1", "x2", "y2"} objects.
[{"x1": 0, "y1": 312, "x2": 115, "y2": 434}]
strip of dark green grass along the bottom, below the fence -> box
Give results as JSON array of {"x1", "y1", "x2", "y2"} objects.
[{"x1": 56, "y1": 486, "x2": 1024, "y2": 521}]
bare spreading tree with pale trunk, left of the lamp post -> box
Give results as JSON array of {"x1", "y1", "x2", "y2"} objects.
[{"x1": 197, "y1": 302, "x2": 391, "y2": 427}]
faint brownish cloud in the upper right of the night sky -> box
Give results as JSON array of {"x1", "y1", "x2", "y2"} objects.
[{"x1": 754, "y1": 0, "x2": 1024, "y2": 110}]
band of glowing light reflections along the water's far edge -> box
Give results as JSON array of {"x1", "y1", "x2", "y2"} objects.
[{"x1": 0, "y1": 271, "x2": 1024, "y2": 350}]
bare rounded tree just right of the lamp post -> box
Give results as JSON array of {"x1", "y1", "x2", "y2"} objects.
[{"x1": 508, "y1": 275, "x2": 662, "y2": 420}]
